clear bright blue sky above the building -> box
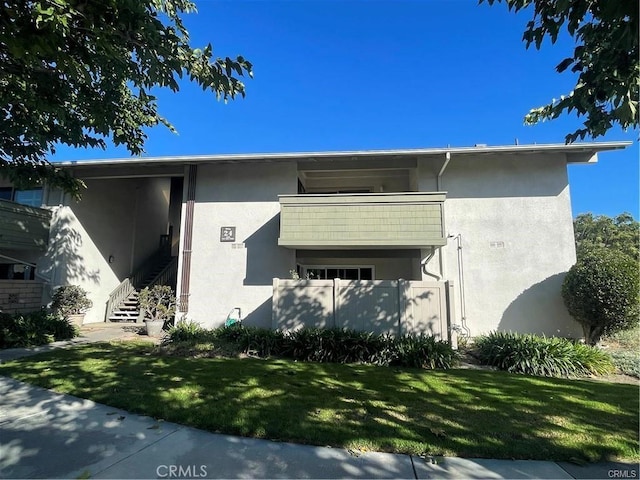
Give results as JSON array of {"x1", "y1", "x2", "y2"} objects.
[{"x1": 54, "y1": 0, "x2": 639, "y2": 218}]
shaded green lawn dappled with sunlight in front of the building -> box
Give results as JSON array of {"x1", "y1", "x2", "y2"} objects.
[{"x1": 0, "y1": 343, "x2": 640, "y2": 461}]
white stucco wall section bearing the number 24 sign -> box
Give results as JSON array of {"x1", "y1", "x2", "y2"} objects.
[{"x1": 178, "y1": 161, "x2": 297, "y2": 328}]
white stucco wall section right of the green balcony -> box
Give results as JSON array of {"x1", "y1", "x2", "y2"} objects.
[{"x1": 418, "y1": 155, "x2": 580, "y2": 337}]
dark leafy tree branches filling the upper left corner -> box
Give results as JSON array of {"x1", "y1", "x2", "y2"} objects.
[{"x1": 0, "y1": 0, "x2": 252, "y2": 196}]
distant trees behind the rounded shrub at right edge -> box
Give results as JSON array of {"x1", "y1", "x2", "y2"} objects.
[{"x1": 573, "y1": 212, "x2": 640, "y2": 261}]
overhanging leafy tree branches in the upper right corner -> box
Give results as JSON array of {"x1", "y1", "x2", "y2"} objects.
[{"x1": 480, "y1": 0, "x2": 640, "y2": 143}]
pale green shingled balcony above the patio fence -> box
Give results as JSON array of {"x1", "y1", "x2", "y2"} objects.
[{"x1": 278, "y1": 192, "x2": 447, "y2": 250}]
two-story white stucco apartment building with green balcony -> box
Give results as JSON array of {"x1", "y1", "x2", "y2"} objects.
[{"x1": 0, "y1": 142, "x2": 628, "y2": 344}]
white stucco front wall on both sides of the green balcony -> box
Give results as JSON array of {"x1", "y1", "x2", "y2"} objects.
[{"x1": 178, "y1": 155, "x2": 580, "y2": 336}]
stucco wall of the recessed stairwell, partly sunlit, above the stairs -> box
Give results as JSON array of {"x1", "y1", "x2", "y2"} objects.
[{"x1": 38, "y1": 178, "x2": 169, "y2": 323}]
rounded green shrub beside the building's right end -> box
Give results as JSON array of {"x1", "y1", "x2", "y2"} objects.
[{"x1": 562, "y1": 248, "x2": 640, "y2": 345}]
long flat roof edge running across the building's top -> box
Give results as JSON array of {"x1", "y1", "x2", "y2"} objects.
[{"x1": 54, "y1": 141, "x2": 633, "y2": 167}]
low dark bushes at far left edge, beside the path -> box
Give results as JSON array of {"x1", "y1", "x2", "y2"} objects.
[{"x1": 0, "y1": 310, "x2": 77, "y2": 348}]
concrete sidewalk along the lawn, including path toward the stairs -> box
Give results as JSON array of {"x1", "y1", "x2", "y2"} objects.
[{"x1": 0, "y1": 326, "x2": 639, "y2": 479}]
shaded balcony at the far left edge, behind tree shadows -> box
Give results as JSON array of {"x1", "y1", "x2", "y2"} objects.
[{"x1": 0, "y1": 200, "x2": 51, "y2": 250}]
